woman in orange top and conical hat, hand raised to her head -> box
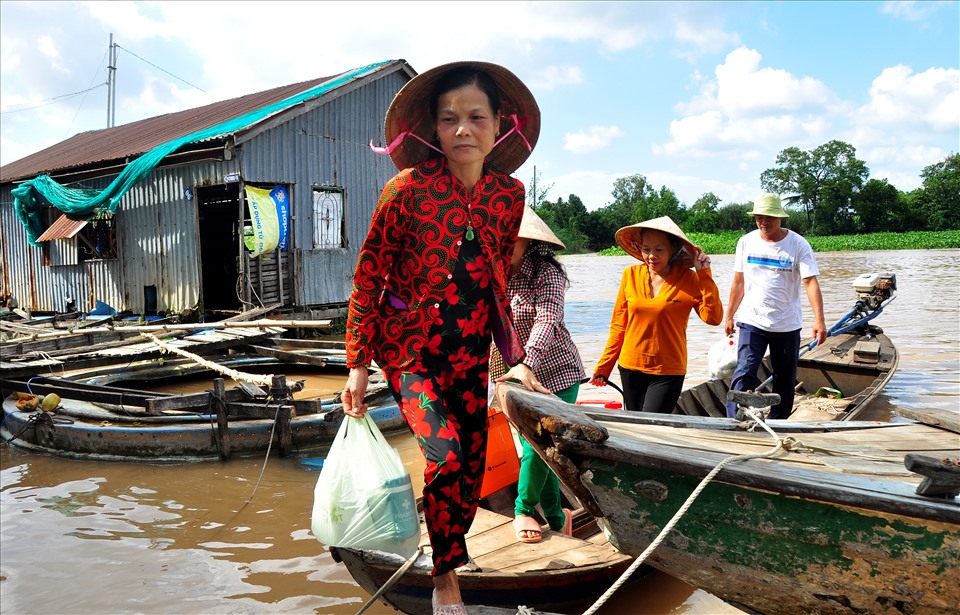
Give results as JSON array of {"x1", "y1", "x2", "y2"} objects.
[{"x1": 590, "y1": 216, "x2": 723, "y2": 412}]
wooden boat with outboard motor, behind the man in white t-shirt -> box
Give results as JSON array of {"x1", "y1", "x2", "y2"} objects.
[{"x1": 673, "y1": 274, "x2": 899, "y2": 420}]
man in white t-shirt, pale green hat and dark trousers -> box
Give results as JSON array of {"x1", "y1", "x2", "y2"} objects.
[{"x1": 724, "y1": 193, "x2": 827, "y2": 419}]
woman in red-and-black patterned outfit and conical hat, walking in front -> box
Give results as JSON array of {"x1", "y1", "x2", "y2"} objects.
[{"x1": 341, "y1": 62, "x2": 540, "y2": 615}]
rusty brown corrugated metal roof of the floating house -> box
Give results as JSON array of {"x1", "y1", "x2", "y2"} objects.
[{"x1": 0, "y1": 61, "x2": 402, "y2": 183}]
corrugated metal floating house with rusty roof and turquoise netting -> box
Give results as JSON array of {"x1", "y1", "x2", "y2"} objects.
[{"x1": 0, "y1": 60, "x2": 416, "y2": 318}]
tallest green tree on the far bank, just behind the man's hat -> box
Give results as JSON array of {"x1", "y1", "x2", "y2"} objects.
[{"x1": 760, "y1": 140, "x2": 869, "y2": 234}]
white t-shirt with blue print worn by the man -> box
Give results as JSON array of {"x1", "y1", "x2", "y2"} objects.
[{"x1": 733, "y1": 230, "x2": 820, "y2": 333}]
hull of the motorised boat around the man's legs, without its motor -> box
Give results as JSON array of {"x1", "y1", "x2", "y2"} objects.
[{"x1": 673, "y1": 325, "x2": 899, "y2": 420}]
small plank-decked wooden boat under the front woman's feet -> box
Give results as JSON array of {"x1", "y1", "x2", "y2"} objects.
[{"x1": 330, "y1": 508, "x2": 632, "y2": 615}]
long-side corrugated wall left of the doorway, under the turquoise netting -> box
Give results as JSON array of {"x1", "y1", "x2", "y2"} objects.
[{"x1": 0, "y1": 160, "x2": 239, "y2": 314}]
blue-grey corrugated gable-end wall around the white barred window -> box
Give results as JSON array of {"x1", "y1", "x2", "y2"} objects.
[{"x1": 241, "y1": 71, "x2": 408, "y2": 306}]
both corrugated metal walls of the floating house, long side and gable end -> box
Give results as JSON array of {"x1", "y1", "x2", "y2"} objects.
[{"x1": 0, "y1": 70, "x2": 408, "y2": 314}]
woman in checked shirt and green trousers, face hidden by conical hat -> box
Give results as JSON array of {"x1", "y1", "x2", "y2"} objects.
[{"x1": 490, "y1": 207, "x2": 586, "y2": 542}]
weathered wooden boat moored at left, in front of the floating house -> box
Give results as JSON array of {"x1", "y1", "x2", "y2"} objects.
[{"x1": 0, "y1": 350, "x2": 406, "y2": 462}]
